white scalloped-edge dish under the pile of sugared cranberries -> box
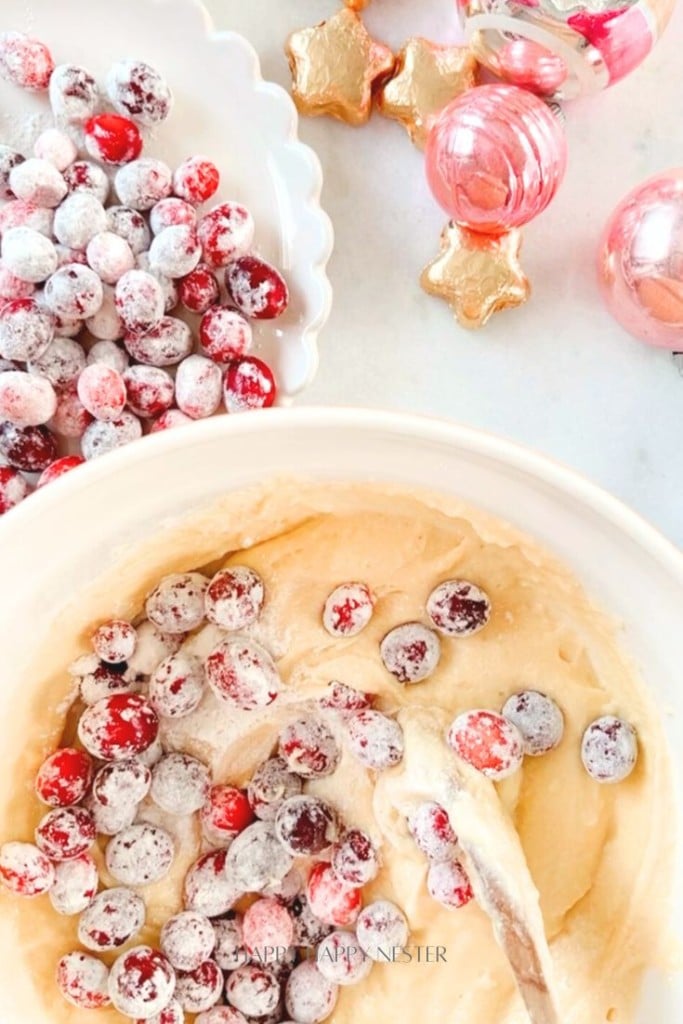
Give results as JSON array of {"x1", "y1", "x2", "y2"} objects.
[{"x1": 0, "y1": 0, "x2": 333, "y2": 403}]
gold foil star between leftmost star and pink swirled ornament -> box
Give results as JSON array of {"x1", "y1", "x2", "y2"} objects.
[{"x1": 378, "y1": 38, "x2": 477, "y2": 150}]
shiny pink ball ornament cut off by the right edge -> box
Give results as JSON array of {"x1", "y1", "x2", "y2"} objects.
[{"x1": 598, "y1": 167, "x2": 683, "y2": 351}]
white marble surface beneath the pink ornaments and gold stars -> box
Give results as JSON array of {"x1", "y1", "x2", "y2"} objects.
[{"x1": 209, "y1": 0, "x2": 683, "y2": 544}]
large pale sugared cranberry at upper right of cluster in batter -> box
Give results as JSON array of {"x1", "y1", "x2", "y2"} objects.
[{"x1": 205, "y1": 637, "x2": 281, "y2": 711}]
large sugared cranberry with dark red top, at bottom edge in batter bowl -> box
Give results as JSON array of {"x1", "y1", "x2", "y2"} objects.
[{"x1": 109, "y1": 946, "x2": 176, "y2": 1020}]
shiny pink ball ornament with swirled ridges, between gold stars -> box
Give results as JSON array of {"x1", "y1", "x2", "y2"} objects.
[{"x1": 426, "y1": 85, "x2": 567, "y2": 234}]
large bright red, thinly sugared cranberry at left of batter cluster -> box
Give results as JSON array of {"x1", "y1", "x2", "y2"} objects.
[{"x1": 78, "y1": 693, "x2": 159, "y2": 761}]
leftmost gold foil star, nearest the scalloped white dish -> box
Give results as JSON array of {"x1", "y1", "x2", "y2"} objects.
[{"x1": 286, "y1": 7, "x2": 394, "y2": 125}]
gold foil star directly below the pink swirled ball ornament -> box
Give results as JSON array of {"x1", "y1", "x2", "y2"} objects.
[{"x1": 420, "y1": 222, "x2": 530, "y2": 328}]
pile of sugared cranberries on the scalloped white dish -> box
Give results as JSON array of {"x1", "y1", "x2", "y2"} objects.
[{"x1": 0, "y1": 32, "x2": 289, "y2": 514}]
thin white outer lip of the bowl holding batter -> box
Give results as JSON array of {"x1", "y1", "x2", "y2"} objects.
[{"x1": 0, "y1": 406, "x2": 683, "y2": 590}]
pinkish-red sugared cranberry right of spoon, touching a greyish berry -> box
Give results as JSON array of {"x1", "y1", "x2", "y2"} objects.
[{"x1": 446, "y1": 710, "x2": 524, "y2": 781}]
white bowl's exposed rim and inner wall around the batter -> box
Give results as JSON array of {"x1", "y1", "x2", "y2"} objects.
[{"x1": 0, "y1": 409, "x2": 683, "y2": 1024}]
